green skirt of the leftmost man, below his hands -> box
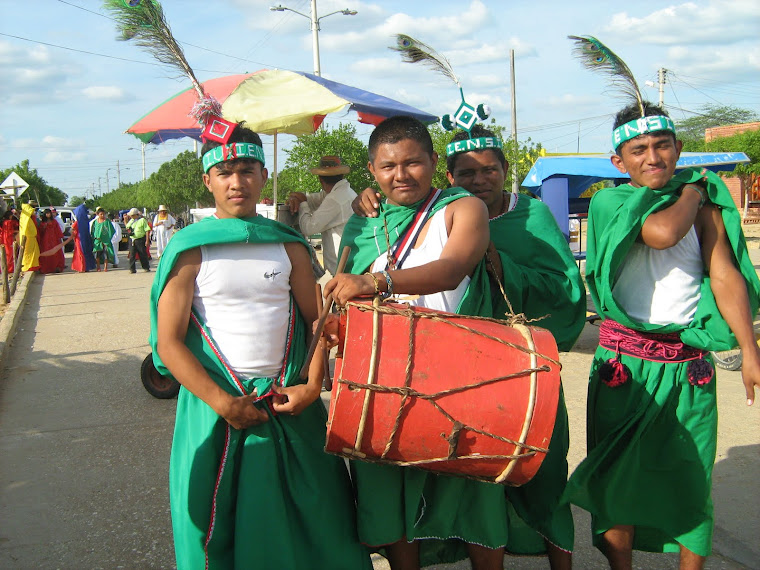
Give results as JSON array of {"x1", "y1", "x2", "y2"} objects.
[{"x1": 170, "y1": 388, "x2": 372, "y2": 570}]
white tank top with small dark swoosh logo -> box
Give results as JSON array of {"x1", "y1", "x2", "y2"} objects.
[{"x1": 193, "y1": 243, "x2": 291, "y2": 378}]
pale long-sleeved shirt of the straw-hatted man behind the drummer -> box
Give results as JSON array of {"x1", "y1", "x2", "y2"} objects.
[{"x1": 298, "y1": 178, "x2": 356, "y2": 275}]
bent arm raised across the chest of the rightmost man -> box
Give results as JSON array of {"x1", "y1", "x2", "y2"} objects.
[{"x1": 640, "y1": 184, "x2": 704, "y2": 249}]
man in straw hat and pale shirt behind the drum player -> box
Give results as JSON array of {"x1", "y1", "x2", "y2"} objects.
[{"x1": 288, "y1": 156, "x2": 356, "y2": 275}]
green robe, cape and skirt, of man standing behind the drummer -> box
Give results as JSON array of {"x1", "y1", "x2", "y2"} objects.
[{"x1": 489, "y1": 194, "x2": 586, "y2": 554}]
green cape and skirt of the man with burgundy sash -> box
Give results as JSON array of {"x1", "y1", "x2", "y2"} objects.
[{"x1": 565, "y1": 169, "x2": 760, "y2": 556}]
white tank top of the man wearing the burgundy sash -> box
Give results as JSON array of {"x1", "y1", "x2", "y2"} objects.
[{"x1": 612, "y1": 226, "x2": 704, "y2": 326}]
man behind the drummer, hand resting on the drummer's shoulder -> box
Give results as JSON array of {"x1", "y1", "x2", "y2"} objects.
[{"x1": 354, "y1": 125, "x2": 586, "y2": 568}]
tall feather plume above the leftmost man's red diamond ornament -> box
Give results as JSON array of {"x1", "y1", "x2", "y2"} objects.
[{"x1": 103, "y1": 0, "x2": 205, "y2": 99}]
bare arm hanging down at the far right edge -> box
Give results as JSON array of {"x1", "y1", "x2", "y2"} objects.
[{"x1": 697, "y1": 205, "x2": 760, "y2": 406}]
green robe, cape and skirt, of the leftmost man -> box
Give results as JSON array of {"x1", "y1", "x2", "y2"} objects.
[{"x1": 150, "y1": 217, "x2": 372, "y2": 570}]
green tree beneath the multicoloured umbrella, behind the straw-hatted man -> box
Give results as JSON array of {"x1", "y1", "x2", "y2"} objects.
[{"x1": 262, "y1": 123, "x2": 372, "y2": 201}]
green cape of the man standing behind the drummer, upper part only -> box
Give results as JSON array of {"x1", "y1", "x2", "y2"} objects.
[{"x1": 490, "y1": 194, "x2": 586, "y2": 351}]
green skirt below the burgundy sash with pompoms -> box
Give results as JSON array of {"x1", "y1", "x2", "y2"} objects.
[{"x1": 565, "y1": 347, "x2": 718, "y2": 556}]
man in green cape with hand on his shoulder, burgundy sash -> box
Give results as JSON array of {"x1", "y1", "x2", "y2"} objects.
[{"x1": 566, "y1": 103, "x2": 760, "y2": 568}]
